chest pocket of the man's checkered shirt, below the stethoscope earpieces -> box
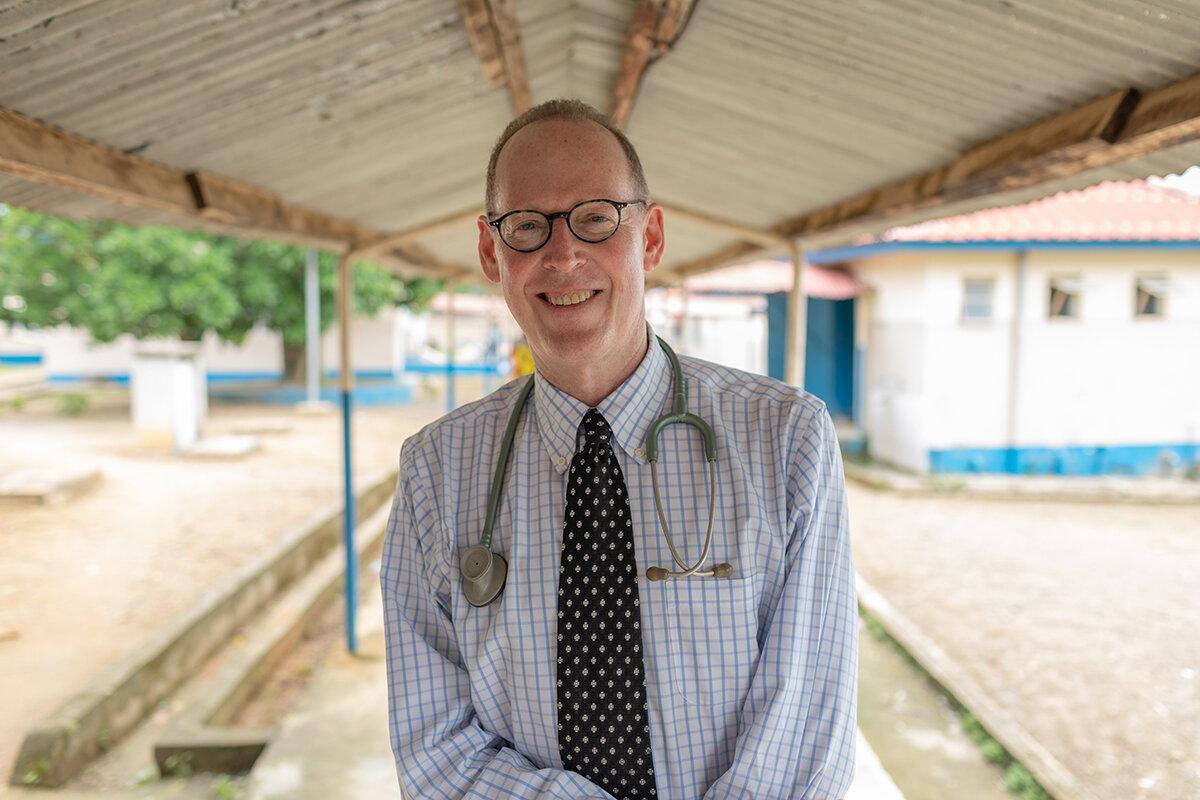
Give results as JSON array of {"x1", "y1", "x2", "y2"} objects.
[{"x1": 650, "y1": 577, "x2": 758, "y2": 712}]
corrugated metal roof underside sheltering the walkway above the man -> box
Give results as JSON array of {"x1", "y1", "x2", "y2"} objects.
[{"x1": 0, "y1": 0, "x2": 1200, "y2": 276}]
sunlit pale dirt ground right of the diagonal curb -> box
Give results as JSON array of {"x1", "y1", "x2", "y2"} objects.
[{"x1": 850, "y1": 485, "x2": 1200, "y2": 800}]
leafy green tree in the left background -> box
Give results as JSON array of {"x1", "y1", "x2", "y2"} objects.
[{"x1": 0, "y1": 205, "x2": 440, "y2": 380}]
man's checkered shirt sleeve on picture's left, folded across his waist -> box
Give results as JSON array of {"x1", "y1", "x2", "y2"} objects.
[{"x1": 380, "y1": 443, "x2": 613, "y2": 800}]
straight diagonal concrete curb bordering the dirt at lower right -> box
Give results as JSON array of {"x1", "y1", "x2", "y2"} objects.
[{"x1": 856, "y1": 575, "x2": 1098, "y2": 800}]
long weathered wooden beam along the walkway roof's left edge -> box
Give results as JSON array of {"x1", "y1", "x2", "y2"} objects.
[{"x1": 0, "y1": 108, "x2": 463, "y2": 275}]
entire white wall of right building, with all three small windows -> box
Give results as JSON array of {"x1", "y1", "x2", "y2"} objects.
[{"x1": 854, "y1": 251, "x2": 1200, "y2": 470}]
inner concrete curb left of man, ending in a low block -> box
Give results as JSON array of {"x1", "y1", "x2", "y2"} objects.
[{"x1": 154, "y1": 504, "x2": 391, "y2": 775}]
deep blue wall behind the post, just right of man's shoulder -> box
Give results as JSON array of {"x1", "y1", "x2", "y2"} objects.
[{"x1": 767, "y1": 293, "x2": 854, "y2": 416}]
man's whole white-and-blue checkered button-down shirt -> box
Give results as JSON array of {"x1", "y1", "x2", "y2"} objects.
[{"x1": 382, "y1": 336, "x2": 858, "y2": 800}]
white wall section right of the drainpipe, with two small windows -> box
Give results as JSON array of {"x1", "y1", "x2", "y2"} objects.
[{"x1": 1016, "y1": 251, "x2": 1200, "y2": 445}]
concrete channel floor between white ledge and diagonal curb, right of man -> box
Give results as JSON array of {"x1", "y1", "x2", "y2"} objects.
[{"x1": 858, "y1": 620, "x2": 1016, "y2": 800}]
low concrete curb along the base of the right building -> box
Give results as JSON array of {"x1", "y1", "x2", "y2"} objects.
[{"x1": 845, "y1": 462, "x2": 1200, "y2": 505}]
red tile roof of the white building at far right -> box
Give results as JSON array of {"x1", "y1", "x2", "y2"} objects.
[{"x1": 880, "y1": 180, "x2": 1200, "y2": 242}]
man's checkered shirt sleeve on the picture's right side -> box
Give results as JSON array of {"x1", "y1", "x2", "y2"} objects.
[{"x1": 704, "y1": 404, "x2": 858, "y2": 800}]
